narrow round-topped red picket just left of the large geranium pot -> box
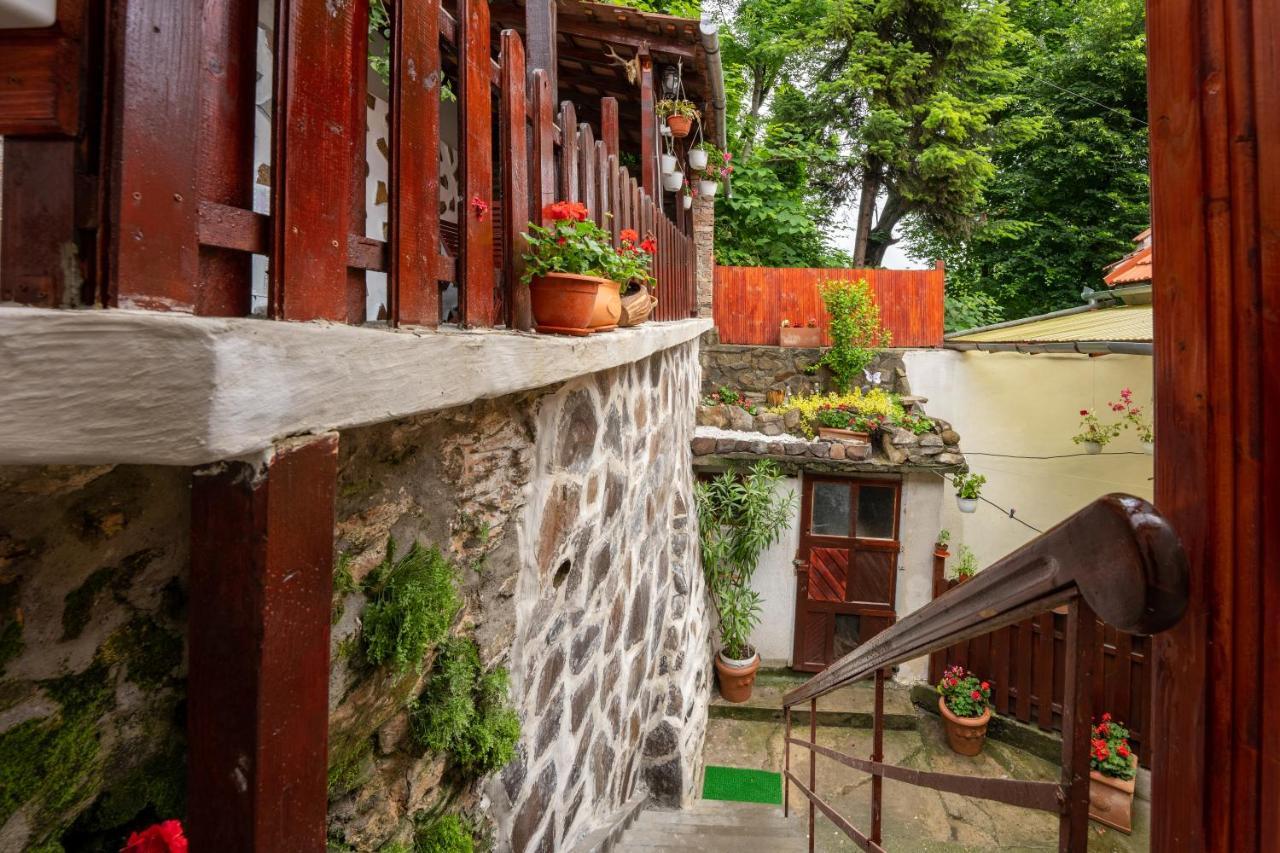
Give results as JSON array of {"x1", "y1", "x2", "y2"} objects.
[{"x1": 500, "y1": 29, "x2": 536, "y2": 330}]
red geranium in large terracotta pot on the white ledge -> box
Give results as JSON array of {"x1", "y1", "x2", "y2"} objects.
[{"x1": 524, "y1": 201, "x2": 653, "y2": 336}]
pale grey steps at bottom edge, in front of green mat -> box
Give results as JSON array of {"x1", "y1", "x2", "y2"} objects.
[{"x1": 612, "y1": 799, "x2": 809, "y2": 853}]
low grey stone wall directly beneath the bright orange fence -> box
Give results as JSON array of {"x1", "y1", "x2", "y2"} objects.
[{"x1": 701, "y1": 342, "x2": 911, "y2": 397}]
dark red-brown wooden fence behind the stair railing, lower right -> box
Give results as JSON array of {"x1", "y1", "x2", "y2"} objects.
[{"x1": 929, "y1": 561, "x2": 1151, "y2": 767}]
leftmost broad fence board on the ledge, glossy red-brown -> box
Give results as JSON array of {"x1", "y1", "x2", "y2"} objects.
[{"x1": 109, "y1": 0, "x2": 204, "y2": 313}]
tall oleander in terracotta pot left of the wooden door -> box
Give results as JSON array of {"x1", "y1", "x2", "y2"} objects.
[{"x1": 694, "y1": 460, "x2": 796, "y2": 702}]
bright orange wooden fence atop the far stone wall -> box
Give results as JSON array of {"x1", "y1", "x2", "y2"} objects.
[{"x1": 714, "y1": 263, "x2": 945, "y2": 347}]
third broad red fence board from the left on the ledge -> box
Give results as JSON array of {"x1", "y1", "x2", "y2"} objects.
[{"x1": 387, "y1": 0, "x2": 440, "y2": 327}]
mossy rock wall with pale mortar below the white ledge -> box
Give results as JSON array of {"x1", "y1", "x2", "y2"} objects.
[{"x1": 0, "y1": 342, "x2": 710, "y2": 853}]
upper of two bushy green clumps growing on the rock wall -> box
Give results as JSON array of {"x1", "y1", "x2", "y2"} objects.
[{"x1": 364, "y1": 539, "x2": 462, "y2": 672}]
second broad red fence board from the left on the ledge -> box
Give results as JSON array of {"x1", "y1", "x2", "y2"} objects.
[{"x1": 268, "y1": 0, "x2": 366, "y2": 321}]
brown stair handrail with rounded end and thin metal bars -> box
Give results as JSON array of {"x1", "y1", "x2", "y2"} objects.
[{"x1": 782, "y1": 494, "x2": 1188, "y2": 853}]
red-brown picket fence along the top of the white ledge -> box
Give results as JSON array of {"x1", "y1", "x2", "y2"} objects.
[{"x1": 0, "y1": 0, "x2": 696, "y2": 329}]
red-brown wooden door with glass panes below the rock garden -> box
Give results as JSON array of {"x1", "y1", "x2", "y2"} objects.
[{"x1": 791, "y1": 475, "x2": 901, "y2": 672}]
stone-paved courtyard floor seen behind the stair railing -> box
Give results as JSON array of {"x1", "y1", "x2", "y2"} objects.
[{"x1": 704, "y1": 697, "x2": 1149, "y2": 853}]
